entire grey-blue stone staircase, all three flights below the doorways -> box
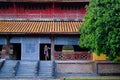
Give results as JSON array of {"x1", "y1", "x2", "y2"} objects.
[{"x1": 0, "y1": 61, "x2": 53, "y2": 79}]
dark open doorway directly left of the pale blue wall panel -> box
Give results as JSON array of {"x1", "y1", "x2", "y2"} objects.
[{"x1": 12, "y1": 43, "x2": 21, "y2": 60}]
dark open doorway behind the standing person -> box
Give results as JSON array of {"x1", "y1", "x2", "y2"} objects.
[{"x1": 39, "y1": 44, "x2": 51, "y2": 60}]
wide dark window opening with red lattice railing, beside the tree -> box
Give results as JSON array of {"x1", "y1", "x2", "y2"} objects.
[{"x1": 54, "y1": 45, "x2": 91, "y2": 60}]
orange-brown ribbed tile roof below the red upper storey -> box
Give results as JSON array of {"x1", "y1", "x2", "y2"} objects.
[{"x1": 0, "y1": 21, "x2": 82, "y2": 34}]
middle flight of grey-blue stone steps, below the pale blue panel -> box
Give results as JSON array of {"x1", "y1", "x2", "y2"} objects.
[{"x1": 16, "y1": 61, "x2": 38, "y2": 77}]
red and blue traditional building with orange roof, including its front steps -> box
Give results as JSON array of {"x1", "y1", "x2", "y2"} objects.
[{"x1": 0, "y1": 0, "x2": 107, "y2": 77}]
